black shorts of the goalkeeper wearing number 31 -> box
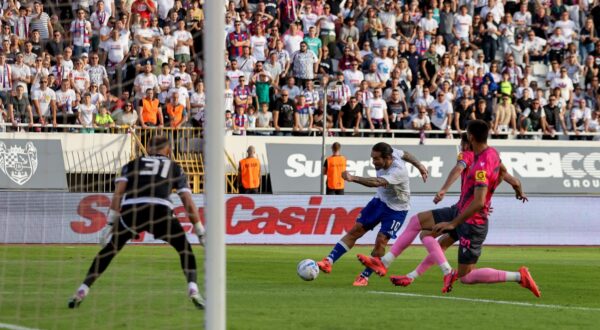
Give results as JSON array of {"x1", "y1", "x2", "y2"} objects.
[{"x1": 118, "y1": 203, "x2": 185, "y2": 241}]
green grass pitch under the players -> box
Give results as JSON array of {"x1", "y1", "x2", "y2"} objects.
[{"x1": 0, "y1": 245, "x2": 600, "y2": 330}]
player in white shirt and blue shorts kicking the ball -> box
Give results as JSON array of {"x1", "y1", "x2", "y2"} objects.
[{"x1": 317, "y1": 142, "x2": 427, "y2": 286}]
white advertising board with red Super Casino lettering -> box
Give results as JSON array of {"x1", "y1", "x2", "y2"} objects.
[{"x1": 0, "y1": 192, "x2": 600, "y2": 245}]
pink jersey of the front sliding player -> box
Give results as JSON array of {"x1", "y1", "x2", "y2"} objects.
[{"x1": 458, "y1": 147, "x2": 501, "y2": 225}]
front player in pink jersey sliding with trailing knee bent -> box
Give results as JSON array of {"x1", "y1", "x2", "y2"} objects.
[{"x1": 356, "y1": 120, "x2": 540, "y2": 297}]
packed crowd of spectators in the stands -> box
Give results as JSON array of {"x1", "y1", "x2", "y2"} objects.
[{"x1": 0, "y1": 0, "x2": 600, "y2": 139}]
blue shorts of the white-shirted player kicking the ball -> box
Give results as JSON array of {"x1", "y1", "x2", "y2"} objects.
[{"x1": 356, "y1": 198, "x2": 408, "y2": 238}]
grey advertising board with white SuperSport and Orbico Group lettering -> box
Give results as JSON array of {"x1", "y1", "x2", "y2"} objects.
[{"x1": 266, "y1": 144, "x2": 600, "y2": 194}]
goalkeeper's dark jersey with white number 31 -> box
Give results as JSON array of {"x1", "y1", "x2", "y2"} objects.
[{"x1": 115, "y1": 155, "x2": 191, "y2": 208}]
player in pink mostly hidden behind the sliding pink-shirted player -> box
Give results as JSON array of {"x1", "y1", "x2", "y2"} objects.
[{"x1": 382, "y1": 133, "x2": 528, "y2": 286}]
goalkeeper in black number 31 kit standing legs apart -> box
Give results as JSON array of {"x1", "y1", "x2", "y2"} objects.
[{"x1": 68, "y1": 136, "x2": 204, "y2": 309}]
